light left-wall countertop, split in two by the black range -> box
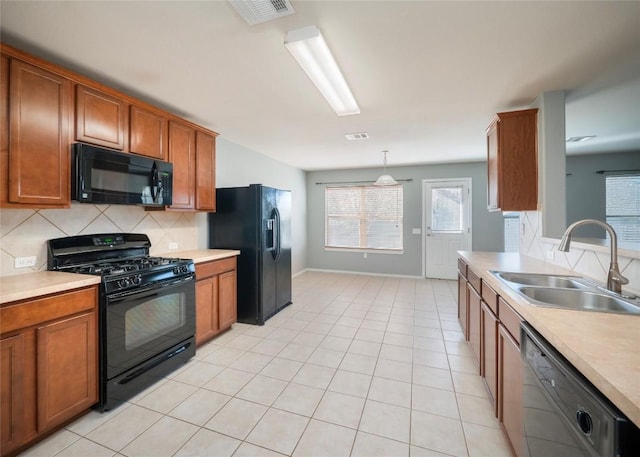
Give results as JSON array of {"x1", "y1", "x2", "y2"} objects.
[{"x1": 0, "y1": 249, "x2": 240, "y2": 304}]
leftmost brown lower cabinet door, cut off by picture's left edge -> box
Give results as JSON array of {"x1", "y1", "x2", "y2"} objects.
[{"x1": 0, "y1": 334, "x2": 25, "y2": 453}]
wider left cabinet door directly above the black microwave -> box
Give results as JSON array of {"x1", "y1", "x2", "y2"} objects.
[{"x1": 76, "y1": 85, "x2": 128, "y2": 151}]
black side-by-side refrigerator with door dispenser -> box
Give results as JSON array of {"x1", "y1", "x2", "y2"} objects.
[{"x1": 209, "y1": 184, "x2": 291, "y2": 325}]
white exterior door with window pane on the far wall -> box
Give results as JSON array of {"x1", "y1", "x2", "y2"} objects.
[{"x1": 422, "y1": 178, "x2": 471, "y2": 279}]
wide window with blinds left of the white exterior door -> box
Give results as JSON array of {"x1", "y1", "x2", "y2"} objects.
[{"x1": 325, "y1": 184, "x2": 403, "y2": 251}]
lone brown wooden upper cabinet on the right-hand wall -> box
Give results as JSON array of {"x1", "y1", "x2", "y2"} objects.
[{"x1": 487, "y1": 109, "x2": 538, "y2": 211}]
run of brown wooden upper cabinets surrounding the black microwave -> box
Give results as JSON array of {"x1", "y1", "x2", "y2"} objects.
[{"x1": 0, "y1": 43, "x2": 217, "y2": 211}]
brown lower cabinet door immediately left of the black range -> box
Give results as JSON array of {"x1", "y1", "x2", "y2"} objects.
[{"x1": 36, "y1": 312, "x2": 98, "y2": 432}]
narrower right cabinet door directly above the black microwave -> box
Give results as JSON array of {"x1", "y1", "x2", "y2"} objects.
[{"x1": 129, "y1": 105, "x2": 167, "y2": 160}]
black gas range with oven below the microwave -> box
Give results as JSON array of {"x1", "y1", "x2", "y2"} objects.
[{"x1": 47, "y1": 233, "x2": 195, "y2": 411}]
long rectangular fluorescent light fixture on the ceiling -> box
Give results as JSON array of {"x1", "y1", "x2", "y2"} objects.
[{"x1": 284, "y1": 25, "x2": 360, "y2": 116}]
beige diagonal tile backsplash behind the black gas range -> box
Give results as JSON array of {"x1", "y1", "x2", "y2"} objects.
[{"x1": 0, "y1": 203, "x2": 197, "y2": 276}]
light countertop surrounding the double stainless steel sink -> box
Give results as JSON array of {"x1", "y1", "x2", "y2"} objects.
[{"x1": 459, "y1": 251, "x2": 640, "y2": 427}]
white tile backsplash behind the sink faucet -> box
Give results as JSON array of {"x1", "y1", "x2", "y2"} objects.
[{"x1": 520, "y1": 211, "x2": 640, "y2": 295}]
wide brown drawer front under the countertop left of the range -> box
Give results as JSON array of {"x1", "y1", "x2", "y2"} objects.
[{"x1": 0, "y1": 286, "x2": 98, "y2": 334}]
